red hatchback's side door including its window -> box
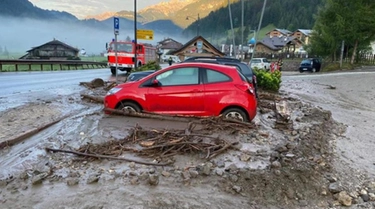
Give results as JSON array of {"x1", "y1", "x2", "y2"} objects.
[{"x1": 146, "y1": 67, "x2": 204, "y2": 115}]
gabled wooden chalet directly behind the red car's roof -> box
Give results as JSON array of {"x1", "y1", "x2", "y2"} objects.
[{"x1": 172, "y1": 36, "x2": 225, "y2": 60}]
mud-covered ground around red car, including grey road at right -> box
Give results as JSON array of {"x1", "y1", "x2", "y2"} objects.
[{"x1": 0, "y1": 68, "x2": 375, "y2": 209}]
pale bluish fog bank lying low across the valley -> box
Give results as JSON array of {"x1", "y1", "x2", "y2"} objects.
[{"x1": 0, "y1": 16, "x2": 187, "y2": 55}]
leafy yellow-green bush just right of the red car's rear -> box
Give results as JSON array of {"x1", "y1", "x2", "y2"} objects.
[{"x1": 253, "y1": 68, "x2": 281, "y2": 92}]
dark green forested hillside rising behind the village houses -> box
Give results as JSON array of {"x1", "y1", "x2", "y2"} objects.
[{"x1": 183, "y1": 0, "x2": 324, "y2": 43}]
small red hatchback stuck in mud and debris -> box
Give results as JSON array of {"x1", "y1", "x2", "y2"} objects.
[{"x1": 104, "y1": 62, "x2": 257, "y2": 121}]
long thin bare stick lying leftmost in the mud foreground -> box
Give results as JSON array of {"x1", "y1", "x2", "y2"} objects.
[{"x1": 45, "y1": 147, "x2": 170, "y2": 166}]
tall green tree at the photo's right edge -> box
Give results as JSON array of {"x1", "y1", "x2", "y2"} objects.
[{"x1": 310, "y1": 0, "x2": 375, "y2": 64}]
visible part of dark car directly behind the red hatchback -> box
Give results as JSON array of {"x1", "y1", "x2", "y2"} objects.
[{"x1": 183, "y1": 56, "x2": 258, "y2": 98}]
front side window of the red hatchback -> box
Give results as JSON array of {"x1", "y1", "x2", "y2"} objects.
[{"x1": 156, "y1": 67, "x2": 199, "y2": 86}]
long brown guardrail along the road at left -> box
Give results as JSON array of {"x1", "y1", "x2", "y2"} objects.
[{"x1": 0, "y1": 59, "x2": 107, "y2": 72}]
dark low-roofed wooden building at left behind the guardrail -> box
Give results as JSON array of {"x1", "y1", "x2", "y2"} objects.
[{"x1": 20, "y1": 39, "x2": 79, "y2": 60}]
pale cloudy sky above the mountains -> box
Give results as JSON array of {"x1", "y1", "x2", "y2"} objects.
[{"x1": 29, "y1": 0, "x2": 169, "y2": 19}]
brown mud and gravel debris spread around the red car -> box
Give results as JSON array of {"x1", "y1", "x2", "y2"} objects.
[{"x1": 0, "y1": 70, "x2": 375, "y2": 208}]
